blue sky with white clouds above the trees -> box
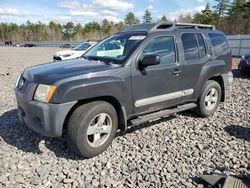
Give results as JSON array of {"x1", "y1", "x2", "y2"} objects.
[{"x1": 0, "y1": 0, "x2": 214, "y2": 24}]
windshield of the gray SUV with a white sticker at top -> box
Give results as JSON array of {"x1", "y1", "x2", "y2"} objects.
[{"x1": 84, "y1": 34, "x2": 146, "y2": 64}]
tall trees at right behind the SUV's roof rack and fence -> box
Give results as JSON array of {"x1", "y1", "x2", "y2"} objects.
[{"x1": 179, "y1": 0, "x2": 250, "y2": 35}]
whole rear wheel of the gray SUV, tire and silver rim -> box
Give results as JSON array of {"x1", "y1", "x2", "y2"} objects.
[{"x1": 196, "y1": 80, "x2": 221, "y2": 117}]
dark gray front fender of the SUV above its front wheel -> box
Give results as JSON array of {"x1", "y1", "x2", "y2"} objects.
[{"x1": 51, "y1": 67, "x2": 133, "y2": 115}]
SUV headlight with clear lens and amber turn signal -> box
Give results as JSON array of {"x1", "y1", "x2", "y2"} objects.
[{"x1": 34, "y1": 84, "x2": 56, "y2": 103}]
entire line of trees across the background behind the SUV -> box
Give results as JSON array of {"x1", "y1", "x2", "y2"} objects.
[{"x1": 0, "y1": 0, "x2": 250, "y2": 41}]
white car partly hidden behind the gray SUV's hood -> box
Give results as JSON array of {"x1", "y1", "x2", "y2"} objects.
[{"x1": 53, "y1": 42, "x2": 97, "y2": 61}]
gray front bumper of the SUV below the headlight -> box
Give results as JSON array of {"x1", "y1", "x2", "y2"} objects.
[{"x1": 17, "y1": 98, "x2": 76, "y2": 137}]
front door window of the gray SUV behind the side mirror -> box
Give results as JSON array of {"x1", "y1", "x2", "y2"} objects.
[{"x1": 142, "y1": 36, "x2": 176, "y2": 64}]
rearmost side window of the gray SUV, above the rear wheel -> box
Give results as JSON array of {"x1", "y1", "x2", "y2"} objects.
[{"x1": 208, "y1": 33, "x2": 229, "y2": 54}]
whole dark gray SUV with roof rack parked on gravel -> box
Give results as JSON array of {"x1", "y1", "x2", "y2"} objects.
[{"x1": 15, "y1": 23, "x2": 233, "y2": 158}]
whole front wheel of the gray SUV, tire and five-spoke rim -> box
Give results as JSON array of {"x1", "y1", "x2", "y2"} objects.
[{"x1": 68, "y1": 101, "x2": 118, "y2": 158}]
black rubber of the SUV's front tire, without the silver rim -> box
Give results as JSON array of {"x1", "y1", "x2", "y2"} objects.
[{"x1": 68, "y1": 101, "x2": 118, "y2": 158}]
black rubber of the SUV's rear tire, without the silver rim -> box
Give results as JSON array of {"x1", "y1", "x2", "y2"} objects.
[{"x1": 195, "y1": 80, "x2": 221, "y2": 117}]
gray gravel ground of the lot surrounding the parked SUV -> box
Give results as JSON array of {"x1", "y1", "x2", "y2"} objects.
[{"x1": 0, "y1": 47, "x2": 250, "y2": 188}]
